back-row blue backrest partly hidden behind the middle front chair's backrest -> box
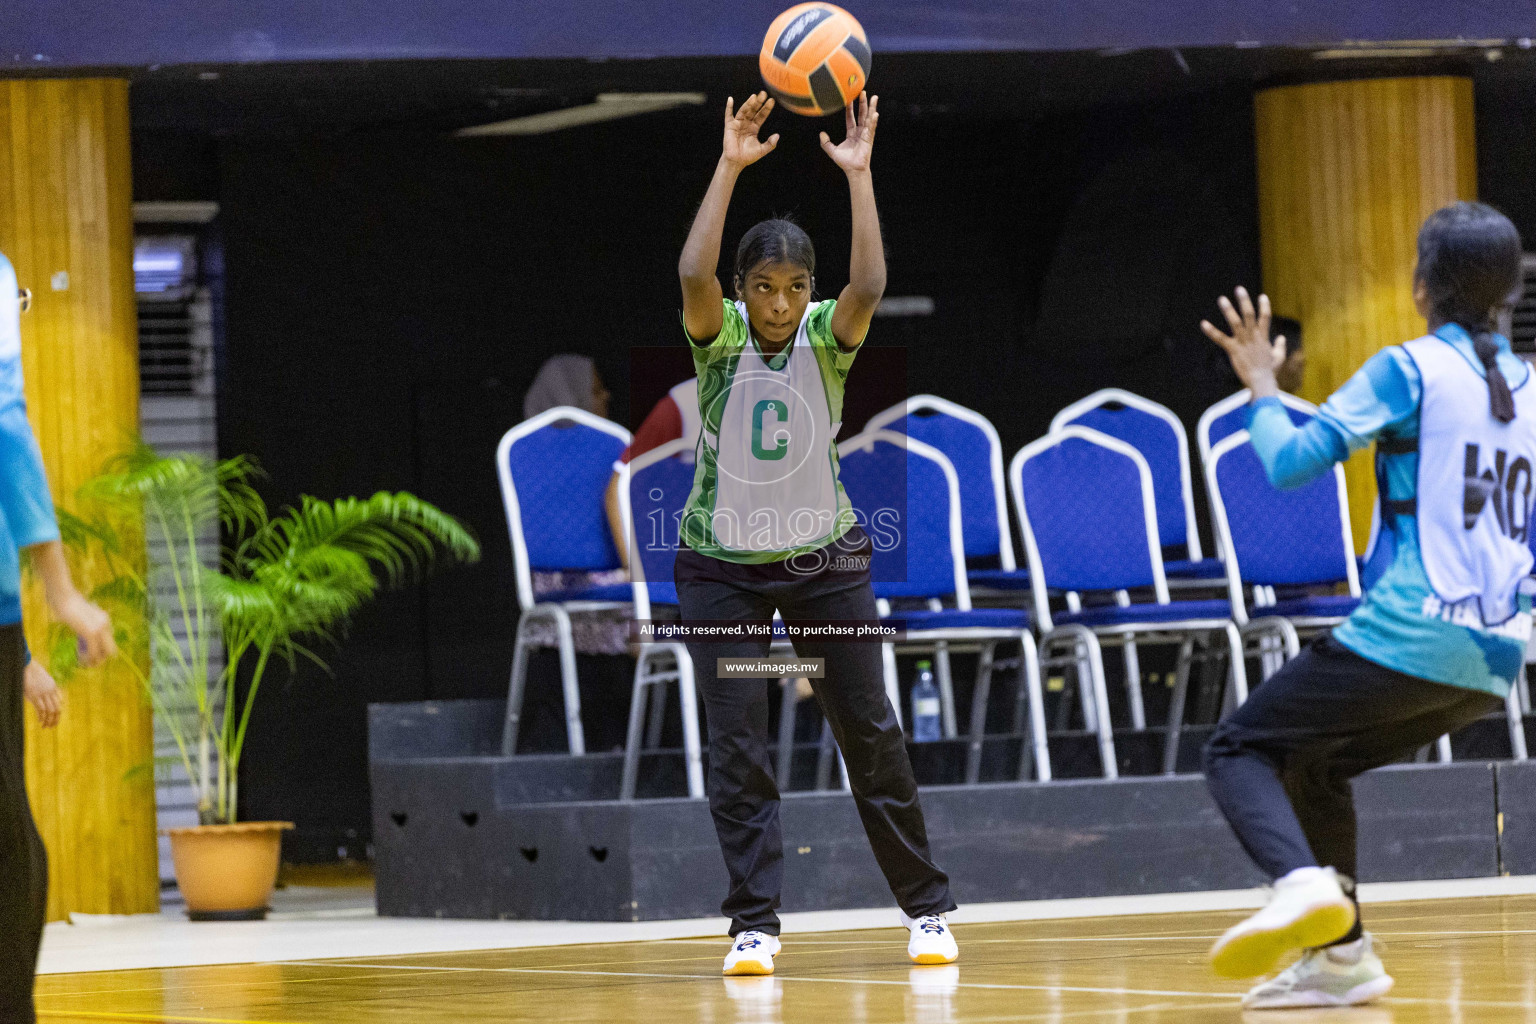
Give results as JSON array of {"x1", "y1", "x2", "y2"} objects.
[{"x1": 1051, "y1": 387, "x2": 1201, "y2": 560}]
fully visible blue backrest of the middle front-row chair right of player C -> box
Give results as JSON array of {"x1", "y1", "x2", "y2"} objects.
[{"x1": 1008, "y1": 425, "x2": 1169, "y2": 629}]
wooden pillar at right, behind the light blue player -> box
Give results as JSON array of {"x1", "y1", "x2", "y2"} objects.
[{"x1": 1255, "y1": 77, "x2": 1478, "y2": 551}]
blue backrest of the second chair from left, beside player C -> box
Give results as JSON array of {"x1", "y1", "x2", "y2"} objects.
[{"x1": 619, "y1": 438, "x2": 694, "y2": 619}]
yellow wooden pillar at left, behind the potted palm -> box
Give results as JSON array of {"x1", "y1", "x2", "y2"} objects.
[{"x1": 0, "y1": 78, "x2": 160, "y2": 920}]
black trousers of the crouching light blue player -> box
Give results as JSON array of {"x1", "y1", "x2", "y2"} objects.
[{"x1": 1203, "y1": 634, "x2": 1502, "y2": 941}]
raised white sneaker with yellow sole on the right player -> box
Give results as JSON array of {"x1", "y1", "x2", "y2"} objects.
[{"x1": 1210, "y1": 867, "x2": 1355, "y2": 978}]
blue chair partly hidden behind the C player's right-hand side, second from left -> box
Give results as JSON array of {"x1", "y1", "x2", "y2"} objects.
[{"x1": 619, "y1": 438, "x2": 703, "y2": 800}]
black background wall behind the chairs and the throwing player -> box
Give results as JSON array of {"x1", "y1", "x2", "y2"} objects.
[{"x1": 135, "y1": 70, "x2": 1536, "y2": 857}]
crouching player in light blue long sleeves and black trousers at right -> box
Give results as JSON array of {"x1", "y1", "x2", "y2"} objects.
[{"x1": 1201, "y1": 203, "x2": 1536, "y2": 1009}]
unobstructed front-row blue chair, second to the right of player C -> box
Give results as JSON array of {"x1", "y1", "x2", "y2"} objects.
[{"x1": 1009, "y1": 425, "x2": 1247, "y2": 778}]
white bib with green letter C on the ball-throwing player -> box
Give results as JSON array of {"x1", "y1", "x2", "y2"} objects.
[{"x1": 703, "y1": 302, "x2": 839, "y2": 551}]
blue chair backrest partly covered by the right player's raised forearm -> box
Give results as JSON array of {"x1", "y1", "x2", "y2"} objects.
[{"x1": 1206, "y1": 430, "x2": 1361, "y2": 614}]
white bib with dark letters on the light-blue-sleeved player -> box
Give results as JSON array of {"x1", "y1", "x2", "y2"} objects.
[{"x1": 1402, "y1": 335, "x2": 1536, "y2": 628}]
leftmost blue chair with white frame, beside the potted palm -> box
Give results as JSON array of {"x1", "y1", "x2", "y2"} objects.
[{"x1": 496, "y1": 405, "x2": 630, "y2": 757}]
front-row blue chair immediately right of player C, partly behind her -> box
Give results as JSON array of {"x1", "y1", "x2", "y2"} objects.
[{"x1": 839, "y1": 430, "x2": 1051, "y2": 781}]
